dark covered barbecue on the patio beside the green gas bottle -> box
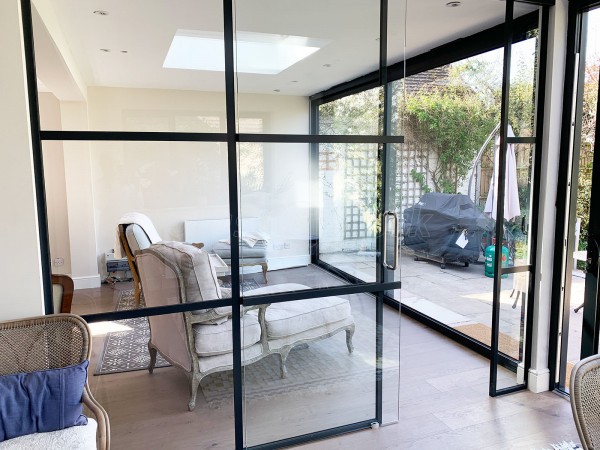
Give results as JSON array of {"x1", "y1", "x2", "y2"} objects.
[{"x1": 403, "y1": 192, "x2": 494, "y2": 269}]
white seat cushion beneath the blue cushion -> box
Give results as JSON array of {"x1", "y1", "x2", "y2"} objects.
[{"x1": 0, "y1": 418, "x2": 98, "y2": 450}]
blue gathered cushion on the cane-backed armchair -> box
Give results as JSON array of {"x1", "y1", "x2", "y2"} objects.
[{"x1": 0, "y1": 360, "x2": 89, "y2": 441}]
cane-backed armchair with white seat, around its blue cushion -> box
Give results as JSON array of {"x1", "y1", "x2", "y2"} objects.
[{"x1": 0, "y1": 314, "x2": 110, "y2": 450}]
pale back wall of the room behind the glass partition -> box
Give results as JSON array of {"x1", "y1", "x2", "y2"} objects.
[{"x1": 85, "y1": 87, "x2": 309, "y2": 272}]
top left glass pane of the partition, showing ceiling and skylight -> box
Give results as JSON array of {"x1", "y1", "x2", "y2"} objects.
[{"x1": 34, "y1": 0, "x2": 226, "y2": 132}]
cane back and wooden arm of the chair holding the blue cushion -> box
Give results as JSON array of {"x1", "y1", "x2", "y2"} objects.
[{"x1": 0, "y1": 314, "x2": 110, "y2": 450}]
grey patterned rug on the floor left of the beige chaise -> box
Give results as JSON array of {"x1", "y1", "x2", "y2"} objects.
[{"x1": 94, "y1": 280, "x2": 259, "y2": 375}]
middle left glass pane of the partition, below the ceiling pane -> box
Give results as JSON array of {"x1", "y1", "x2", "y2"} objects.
[{"x1": 43, "y1": 141, "x2": 229, "y2": 312}]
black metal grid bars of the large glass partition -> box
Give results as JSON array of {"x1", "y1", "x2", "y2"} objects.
[{"x1": 21, "y1": 0, "x2": 403, "y2": 449}]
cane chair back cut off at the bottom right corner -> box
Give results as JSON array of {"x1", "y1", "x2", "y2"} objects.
[{"x1": 570, "y1": 355, "x2": 600, "y2": 450}]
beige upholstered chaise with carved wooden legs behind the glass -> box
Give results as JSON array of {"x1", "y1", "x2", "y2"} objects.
[{"x1": 136, "y1": 242, "x2": 355, "y2": 410}]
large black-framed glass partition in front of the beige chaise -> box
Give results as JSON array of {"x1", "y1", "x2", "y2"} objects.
[{"x1": 22, "y1": 0, "x2": 405, "y2": 448}]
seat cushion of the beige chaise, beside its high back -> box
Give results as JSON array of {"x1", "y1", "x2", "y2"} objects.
[{"x1": 194, "y1": 314, "x2": 260, "y2": 356}]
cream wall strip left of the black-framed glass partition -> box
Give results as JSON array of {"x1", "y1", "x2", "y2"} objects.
[{"x1": 0, "y1": 0, "x2": 44, "y2": 320}]
